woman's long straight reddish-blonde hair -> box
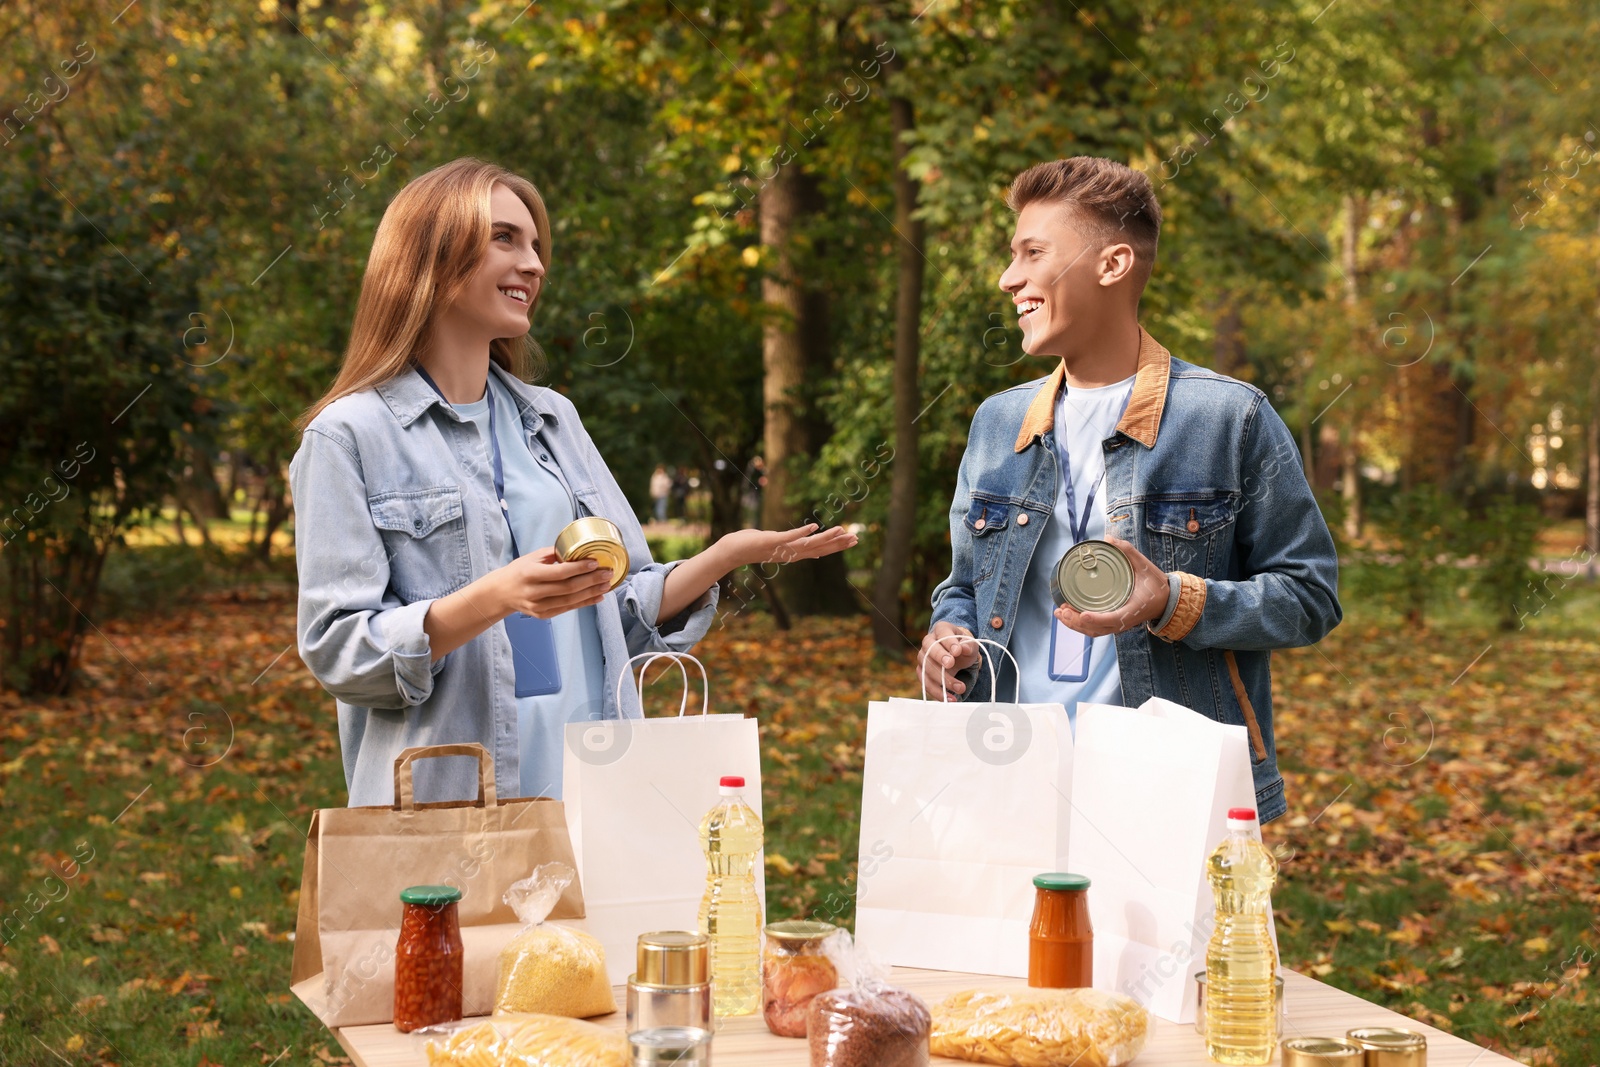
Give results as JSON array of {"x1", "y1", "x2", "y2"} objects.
[{"x1": 299, "y1": 157, "x2": 550, "y2": 429}]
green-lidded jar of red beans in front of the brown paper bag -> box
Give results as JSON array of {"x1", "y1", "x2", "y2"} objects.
[{"x1": 395, "y1": 886, "x2": 462, "y2": 1033}]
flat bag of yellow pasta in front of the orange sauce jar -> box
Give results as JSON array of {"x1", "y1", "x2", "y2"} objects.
[{"x1": 930, "y1": 989, "x2": 1150, "y2": 1067}]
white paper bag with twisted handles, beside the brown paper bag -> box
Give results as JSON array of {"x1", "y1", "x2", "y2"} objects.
[{"x1": 562, "y1": 653, "x2": 766, "y2": 984}]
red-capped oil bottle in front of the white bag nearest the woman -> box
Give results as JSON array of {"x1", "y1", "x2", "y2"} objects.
[{"x1": 701, "y1": 776, "x2": 762, "y2": 1016}]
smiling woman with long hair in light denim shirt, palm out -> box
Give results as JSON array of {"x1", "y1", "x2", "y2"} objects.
[{"x1": 290, "y1": 158, "x2": 856, "y2": 806}]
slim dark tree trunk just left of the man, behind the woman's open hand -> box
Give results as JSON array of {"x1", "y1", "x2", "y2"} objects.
[{"x1": 872, "y1": 96, "x2": 926, "y2": 653}]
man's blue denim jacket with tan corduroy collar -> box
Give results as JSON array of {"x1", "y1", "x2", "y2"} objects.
[{"x1": 933, "y1": 328, "x2": 1344, "y2": 822}]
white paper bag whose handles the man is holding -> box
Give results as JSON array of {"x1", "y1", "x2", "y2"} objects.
[{"x1": 856, "y1": 641, "x2": 1072, "y2": 976}]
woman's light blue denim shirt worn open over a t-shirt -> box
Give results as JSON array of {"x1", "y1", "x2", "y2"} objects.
[{"x1": 290, "y1": 362, "x2": 717, "y2": 806}]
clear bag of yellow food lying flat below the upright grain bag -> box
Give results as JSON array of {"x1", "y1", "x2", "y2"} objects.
[{"x1": 427, "y1": 1014, "x2": 629, "y2": 1067}]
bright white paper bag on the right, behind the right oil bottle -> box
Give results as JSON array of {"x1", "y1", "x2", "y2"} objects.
[{"x1": 1067, "y1": 697, "x2": 1275, "y2": 1022}]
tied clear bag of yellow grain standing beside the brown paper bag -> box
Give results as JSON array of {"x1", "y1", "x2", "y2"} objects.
[{"x1": 494, "y1": 864, "x2": 616, "y2": 1019}]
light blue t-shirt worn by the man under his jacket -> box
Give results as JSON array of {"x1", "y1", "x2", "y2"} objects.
[{"x1": 998, "y1": 378, "x2": 1134, "y2": 728}]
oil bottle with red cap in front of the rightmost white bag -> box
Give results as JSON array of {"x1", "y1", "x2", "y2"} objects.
[{"x1": 1205, "y1": 808, "x2": 1278, "y2": 1064}]
